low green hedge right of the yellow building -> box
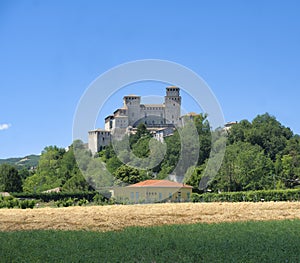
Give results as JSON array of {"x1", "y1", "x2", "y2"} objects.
[{"x1": 191, "y1": 189, "x2": 300, "y2": 202}]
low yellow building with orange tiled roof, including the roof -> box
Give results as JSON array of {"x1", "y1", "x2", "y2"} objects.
[{"x1": 112, "y1": 180, "x2": 193, "y2": 203}]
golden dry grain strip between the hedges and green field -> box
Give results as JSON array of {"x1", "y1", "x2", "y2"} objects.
[{"x1": 0, "y1": 202, "x2": 300, "y2": 231}]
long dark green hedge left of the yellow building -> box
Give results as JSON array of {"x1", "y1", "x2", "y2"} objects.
[{"x1": 13, "y1": 192, "x2": 106, "y2": 202}]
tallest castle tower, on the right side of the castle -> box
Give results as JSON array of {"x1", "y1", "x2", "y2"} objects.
[{"x1": 165, "y1": 86, "x2": 181, "y2": 125}]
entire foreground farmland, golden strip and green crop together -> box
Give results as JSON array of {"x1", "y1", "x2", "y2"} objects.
[{"x1": 0, "y1": 202, "x2": 300, "y2": 263}]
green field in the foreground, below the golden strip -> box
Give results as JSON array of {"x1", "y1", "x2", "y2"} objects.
[{"x1": 0, "y1": 220, "x2": 300, "y2": 262}]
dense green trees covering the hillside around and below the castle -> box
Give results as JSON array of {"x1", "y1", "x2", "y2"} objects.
[{"x1": 0, "y1": 113, "x2": 300, "y2": 195}]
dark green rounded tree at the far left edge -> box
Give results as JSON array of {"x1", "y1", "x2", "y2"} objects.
[{"x1": 0, "y1": 164, "x2": 22, "y2": 192}]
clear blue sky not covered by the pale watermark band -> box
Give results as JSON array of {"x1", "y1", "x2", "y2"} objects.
[{"x1": 0, "y1": 0, "x2": 300, "y2": 158}]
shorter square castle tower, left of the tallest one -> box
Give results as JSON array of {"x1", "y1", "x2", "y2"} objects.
[{"x1": 123, "y1": 95, "x2": 141, "y2": 126}]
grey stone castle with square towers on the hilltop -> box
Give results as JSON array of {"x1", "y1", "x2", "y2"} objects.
[{"x1": 88, "y1": 86, "x2": 181, "y2": 154}]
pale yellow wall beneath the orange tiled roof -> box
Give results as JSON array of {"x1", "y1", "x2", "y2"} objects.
[{"x1": 113, "y1": 187, "x2": 192, "y2": 203}]
